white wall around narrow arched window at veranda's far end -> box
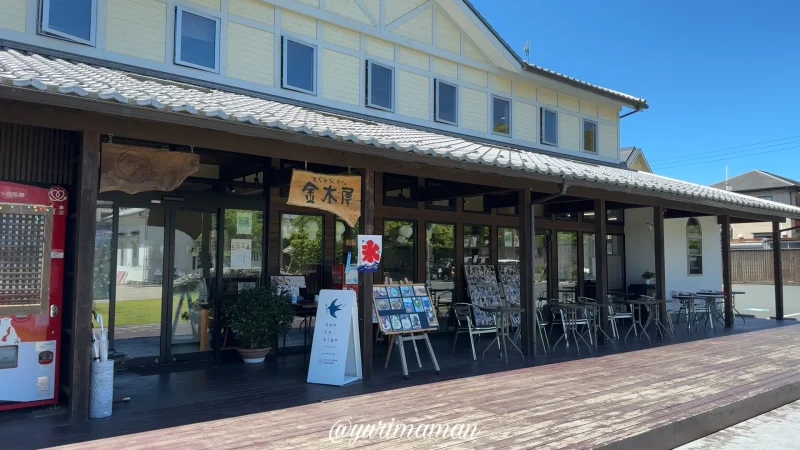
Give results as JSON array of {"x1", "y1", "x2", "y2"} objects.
[{"x1": 625, "y1": 208, "x2": 722, "y2": 297}]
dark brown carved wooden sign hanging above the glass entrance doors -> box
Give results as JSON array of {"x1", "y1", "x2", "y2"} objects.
[{"x1": 100, "y1": 144, "x2": 200, "y2": 194}]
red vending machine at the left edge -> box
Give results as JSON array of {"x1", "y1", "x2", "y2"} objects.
[{"x1": 0, "y1": 182, "x2": 67, "y2": 410}]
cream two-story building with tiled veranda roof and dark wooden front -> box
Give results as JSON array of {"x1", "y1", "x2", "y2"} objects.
[{"x1": 0, "y1": 0, "x2": 800, "y2": 419}]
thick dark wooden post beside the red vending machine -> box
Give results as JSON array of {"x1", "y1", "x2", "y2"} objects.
[{"x1": 65, "y1": 131, "x2": 100, "y2": 423}]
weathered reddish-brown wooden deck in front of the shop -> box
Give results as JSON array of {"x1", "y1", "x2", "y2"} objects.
[{"x1": 0, "y1": 320, "x2": 800, "y2": 450}]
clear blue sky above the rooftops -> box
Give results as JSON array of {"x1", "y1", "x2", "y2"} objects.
[{"x1": 472, "y1": 0, "x2": 800, "y2": 184}]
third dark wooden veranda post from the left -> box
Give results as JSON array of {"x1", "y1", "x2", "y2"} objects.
[{"x1": 518, "y1": 189, "x2": 536, "y2": 356}]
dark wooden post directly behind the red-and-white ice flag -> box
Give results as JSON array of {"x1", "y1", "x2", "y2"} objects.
[{"x1": 356, "y1": 169, "x2": 375, "y2": 380}]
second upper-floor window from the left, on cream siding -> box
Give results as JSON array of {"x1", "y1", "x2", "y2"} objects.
[{"x1": 175, "y1": 6, "x2": 220, "y2": 72}]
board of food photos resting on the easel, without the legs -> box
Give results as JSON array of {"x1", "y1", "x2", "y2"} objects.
[{"x1": 372, "y1": 284, "x2": 439, "y2": 334}]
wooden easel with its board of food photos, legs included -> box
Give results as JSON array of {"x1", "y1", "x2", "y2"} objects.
[{"x1": 372, "y1": 284, "x2": 439, "y2": 379}]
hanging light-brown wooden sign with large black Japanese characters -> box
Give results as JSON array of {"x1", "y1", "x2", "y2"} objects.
[{"x1": 287, "y1": 170, "x2": 361, "y2": 227}]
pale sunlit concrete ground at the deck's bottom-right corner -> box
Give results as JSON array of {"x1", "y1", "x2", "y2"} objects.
[{"x1": 678, "y1": 401, "x2": 800, "y2": 450}]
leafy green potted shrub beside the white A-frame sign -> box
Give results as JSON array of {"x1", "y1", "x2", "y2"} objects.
[{"x1": 229, "y1": 285, "x2": 294, "y2": 363}]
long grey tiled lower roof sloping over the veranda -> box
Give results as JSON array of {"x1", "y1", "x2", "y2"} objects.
[{"x1": 0, "y1": 47, "x2": 800, "y2": 218}]
